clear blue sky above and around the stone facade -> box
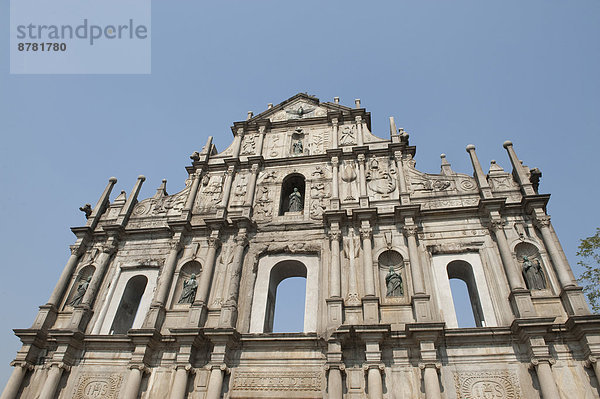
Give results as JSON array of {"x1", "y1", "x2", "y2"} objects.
[{"x1": 0, "y1": 0, "x2": 600, "y2": 387}]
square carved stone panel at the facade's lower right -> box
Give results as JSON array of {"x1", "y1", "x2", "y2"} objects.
[{"x1": 454, "y1": 371, "x2": 521, "y2": 399}]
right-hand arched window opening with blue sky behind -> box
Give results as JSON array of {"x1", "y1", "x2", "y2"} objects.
[{"x1": 446, "y1": 260, "x2": 485, "y2": 328}]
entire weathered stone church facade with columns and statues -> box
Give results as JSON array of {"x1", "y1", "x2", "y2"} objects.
[{"x1": 1, "y1": 94, "x2": 600, "y2": 399}]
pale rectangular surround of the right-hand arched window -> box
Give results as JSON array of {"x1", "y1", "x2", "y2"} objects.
[{"x1": 432, "y1": 252, "x2": 498, "y2": 328}]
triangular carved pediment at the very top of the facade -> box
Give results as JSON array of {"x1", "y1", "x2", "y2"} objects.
[{"x1": 250, "y1": 93, "x2": 352, "y2": 122}]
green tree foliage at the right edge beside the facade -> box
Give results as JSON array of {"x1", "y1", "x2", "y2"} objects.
[{"x1": 577, "y1": 228, "x2": 600, "y2": 313}]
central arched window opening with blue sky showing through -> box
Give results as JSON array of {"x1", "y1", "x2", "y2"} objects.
[{"x1": 263, "y1": 260, "x2": 307, "y2": 333}]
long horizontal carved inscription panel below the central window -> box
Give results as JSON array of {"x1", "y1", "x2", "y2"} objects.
[{"x1": 233, "y1": 371, "x2": 322, "y2": 391}]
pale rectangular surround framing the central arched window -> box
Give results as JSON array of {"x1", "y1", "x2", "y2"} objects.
[{"x1": 250, "y1": 254, "x2": 319, "y2": 333}]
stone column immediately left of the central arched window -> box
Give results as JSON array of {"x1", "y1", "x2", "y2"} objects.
[{"x1": 219, "y1": 228, "x2": 248, "y2": 328}]
